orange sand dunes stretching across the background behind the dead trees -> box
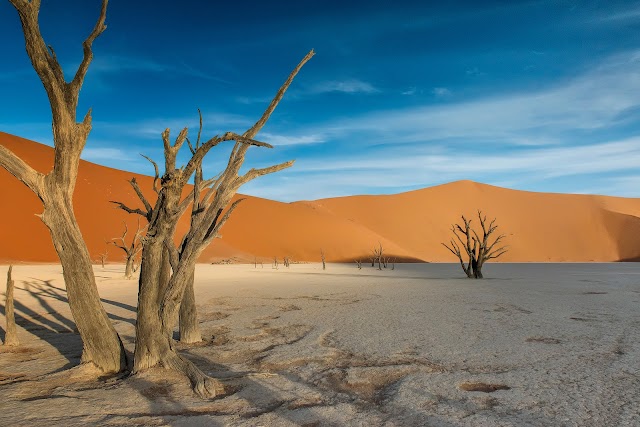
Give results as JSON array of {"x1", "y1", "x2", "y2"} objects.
[{"x1": 0, "y1": 132, "x2": 640, "y2": 263}]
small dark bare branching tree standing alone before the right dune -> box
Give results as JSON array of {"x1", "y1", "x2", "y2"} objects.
[{"x1": 442, "y1": 210, "x2": 507, "y2": 279}]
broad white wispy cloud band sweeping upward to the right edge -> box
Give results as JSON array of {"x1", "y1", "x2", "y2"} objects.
[{"x1": 319, "y1": 51, "x2": 640, "y2": 145}]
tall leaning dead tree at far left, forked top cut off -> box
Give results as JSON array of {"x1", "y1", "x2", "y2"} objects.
[{"x1": 0, "y1": 0, "x2": 127, "y2": 372}]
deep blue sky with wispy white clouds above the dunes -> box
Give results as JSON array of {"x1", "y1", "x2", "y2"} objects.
[{"x1": 0, "y1": 0, "x2": 640, "y2": 201}]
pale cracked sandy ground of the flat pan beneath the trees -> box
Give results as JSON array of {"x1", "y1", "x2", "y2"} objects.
[{"x1": 0, "y1": 264, "x2": 640, "y2": 426}]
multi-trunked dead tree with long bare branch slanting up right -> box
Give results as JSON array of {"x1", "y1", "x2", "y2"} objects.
[{"x1": 116, "y1": 51, "x2": 313, "y2": 397}]
